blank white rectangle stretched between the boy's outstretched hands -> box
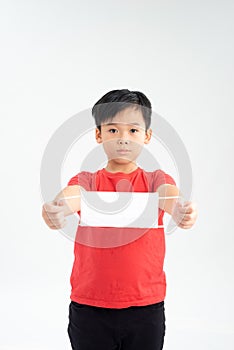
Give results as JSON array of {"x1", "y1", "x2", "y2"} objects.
[{"x1": 80, "y1": 191, "x2": 158, "y2": 228}]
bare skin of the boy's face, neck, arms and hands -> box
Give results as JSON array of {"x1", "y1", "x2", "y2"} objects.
[{"x1": 42, "y1": 108, "x2": 198, "y2": 229}]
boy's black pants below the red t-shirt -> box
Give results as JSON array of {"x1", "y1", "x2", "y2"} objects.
[{"x1": 67, "y1": 301, "x2": 165, "y2": 350}]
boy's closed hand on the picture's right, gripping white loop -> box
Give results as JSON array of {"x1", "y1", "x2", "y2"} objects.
[{"x1": 172, "y1": 202, "x2": 198, "y2": 229}]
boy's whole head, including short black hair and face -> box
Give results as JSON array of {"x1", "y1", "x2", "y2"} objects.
[{"x1": 92, "y1": 89, "x2": 152, "y2": 168}]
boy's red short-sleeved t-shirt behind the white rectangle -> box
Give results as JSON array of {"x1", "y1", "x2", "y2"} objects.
[{"x1": 68, "y1": 167, "x2": 175, "y2": 309}]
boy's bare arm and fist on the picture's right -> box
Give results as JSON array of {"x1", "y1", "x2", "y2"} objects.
[{"x1": 157, "y1": 184, "x2": 198, "y2": 229}]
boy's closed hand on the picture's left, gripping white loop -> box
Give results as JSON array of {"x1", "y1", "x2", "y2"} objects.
[{"x1": 42, "y1": 201, "x2": 66, "y2": 230}]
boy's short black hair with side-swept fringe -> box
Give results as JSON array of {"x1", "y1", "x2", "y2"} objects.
[{"x1": 92, "y1": 89, "x2": 152, "y2": 130}]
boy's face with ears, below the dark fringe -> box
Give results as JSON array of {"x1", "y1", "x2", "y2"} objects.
[{"x1": 96, "y1": 107, "x2": 152, "y2": 165}]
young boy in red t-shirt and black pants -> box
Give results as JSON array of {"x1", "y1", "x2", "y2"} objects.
[{"x1": 42, "y1": 89, "x2": 197, "y2": 350}]
